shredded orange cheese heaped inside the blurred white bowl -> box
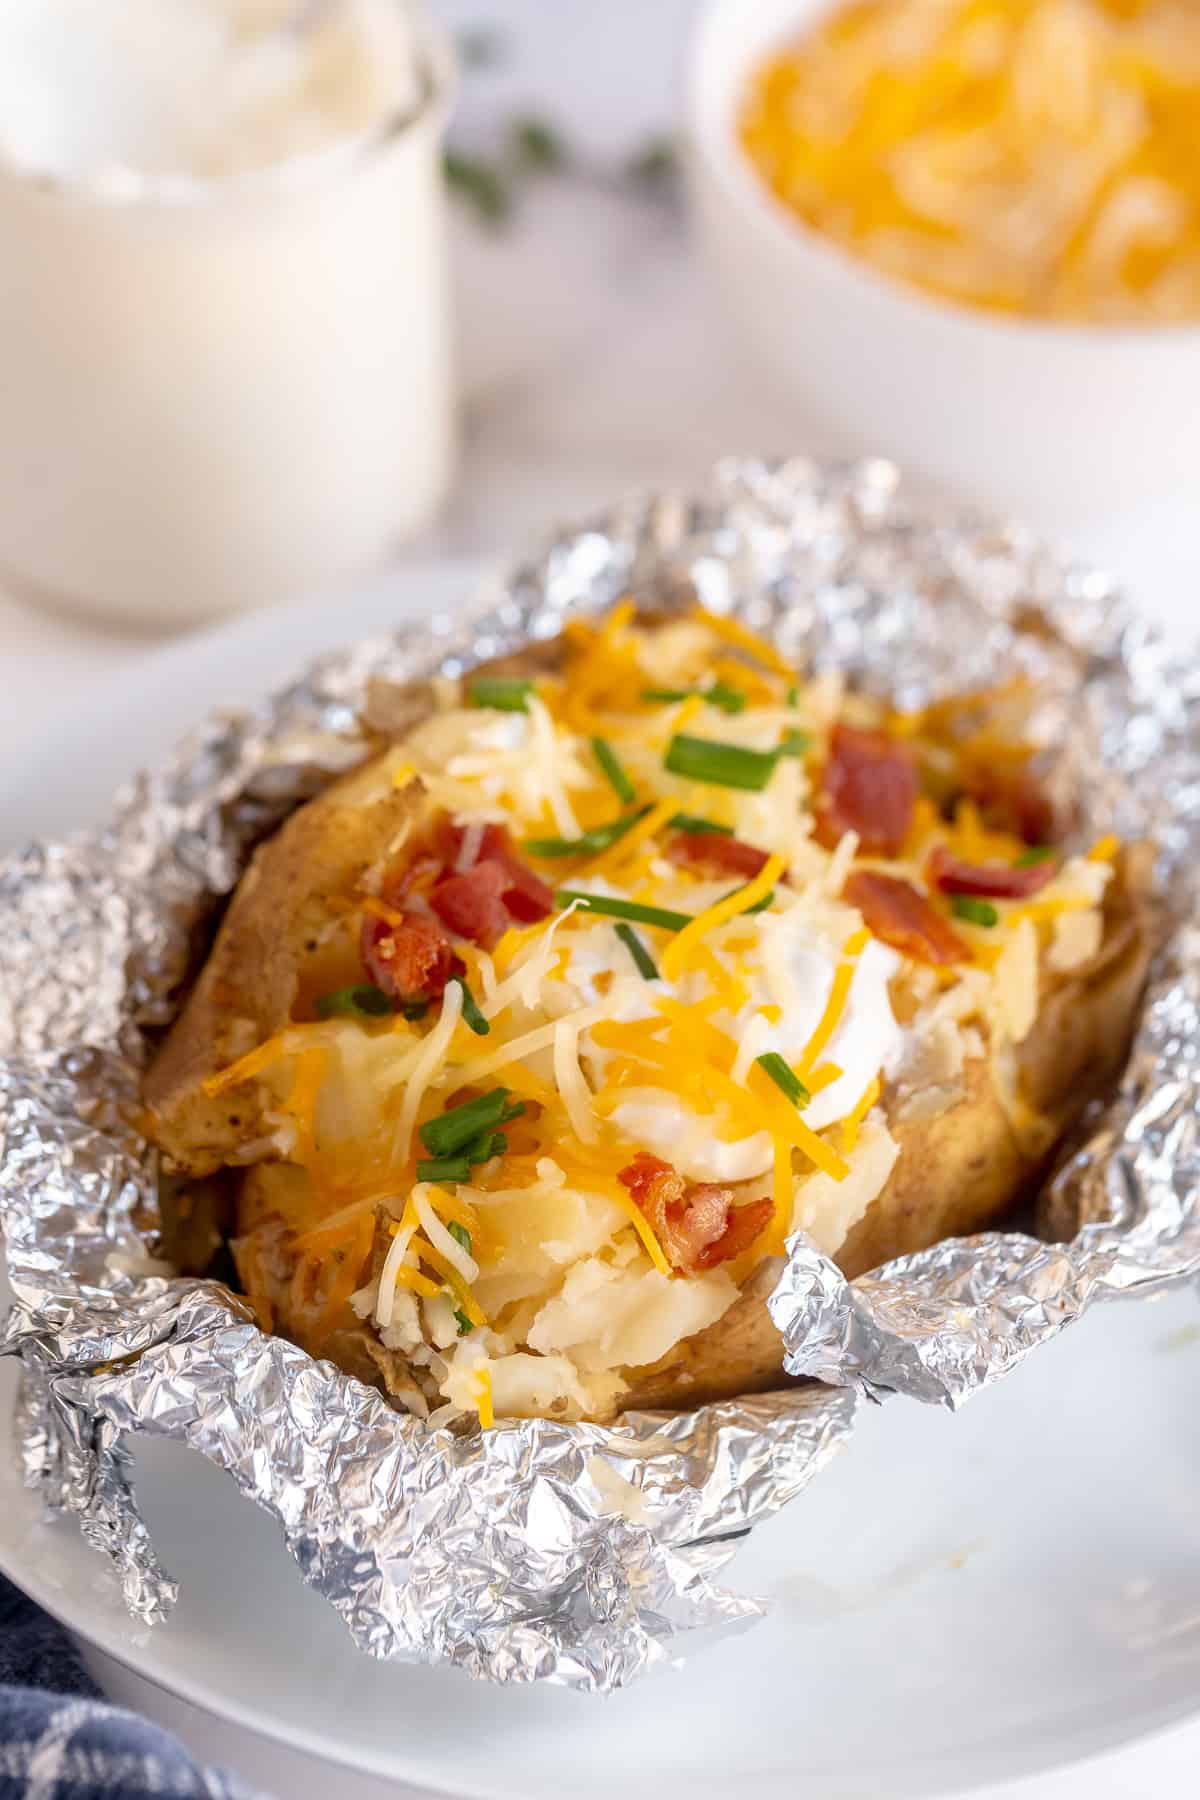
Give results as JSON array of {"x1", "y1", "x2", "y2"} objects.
[{"x1": 739, "y1": 0, "x2": 1200, "y2": 324}]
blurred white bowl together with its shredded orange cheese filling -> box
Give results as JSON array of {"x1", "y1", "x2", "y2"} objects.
[{"x1": 689, "y1": 0, "x2": 1200, "y2": 524}]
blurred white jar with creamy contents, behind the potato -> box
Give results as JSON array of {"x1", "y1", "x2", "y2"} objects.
[{"x1": 0, "y1": 0, "x2": 455, "y2": 625}]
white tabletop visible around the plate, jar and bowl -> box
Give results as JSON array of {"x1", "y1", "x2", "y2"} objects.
[{"x1": 0, "y1": 0, "x2": 1200, "y2": 1800}]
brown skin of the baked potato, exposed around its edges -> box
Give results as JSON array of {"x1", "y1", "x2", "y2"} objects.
[{"x1": 144, "y1": 643, "x2": 1151, "y2": 1409}]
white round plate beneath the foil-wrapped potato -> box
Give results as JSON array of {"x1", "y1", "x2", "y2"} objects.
[{"x1": 0, "y1": 563, "x2": 1200, "y2": 1800}]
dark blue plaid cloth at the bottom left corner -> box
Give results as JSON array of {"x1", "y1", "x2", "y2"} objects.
[{"x1": 0, "y1": 1577, "x2": 264, "y2": 1800}]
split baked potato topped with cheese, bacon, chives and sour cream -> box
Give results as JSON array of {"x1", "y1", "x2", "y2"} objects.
[{"x1": 144, "y1": 603, "x2": 1150, "y2": 1424}]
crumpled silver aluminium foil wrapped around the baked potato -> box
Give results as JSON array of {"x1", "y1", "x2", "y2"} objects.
[{"x1": 0, "y1": 459, "x2": 1200, "y2": 1690}]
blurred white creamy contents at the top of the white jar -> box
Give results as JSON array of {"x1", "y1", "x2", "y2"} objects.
[{"x1": 0, "y1": 0, "x2": 419, "y2": 180}]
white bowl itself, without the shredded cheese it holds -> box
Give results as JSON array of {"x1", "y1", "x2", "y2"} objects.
[{"x1": 687, "y1": 0, "x2": 1200, "y2": 524}]
